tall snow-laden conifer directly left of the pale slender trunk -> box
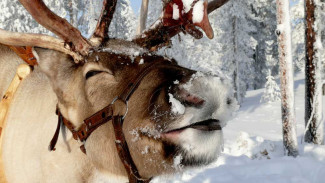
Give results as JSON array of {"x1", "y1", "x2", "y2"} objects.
[{"x1": 251, "y1": 0, "x2": 279, "y2": 89}]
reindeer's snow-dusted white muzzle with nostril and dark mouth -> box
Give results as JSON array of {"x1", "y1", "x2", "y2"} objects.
[{"x1": 158, "y1": 72, "x2": 238, "y2": 167}]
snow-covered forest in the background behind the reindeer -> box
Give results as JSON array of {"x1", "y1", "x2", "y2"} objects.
[{"x1": 0, "y1": 0, "x2": 318, "y2": 103}]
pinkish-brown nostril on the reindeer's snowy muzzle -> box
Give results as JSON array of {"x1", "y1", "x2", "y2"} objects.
[{"x1": 174, "y1": 86, "x2": 205, "y2": 108}]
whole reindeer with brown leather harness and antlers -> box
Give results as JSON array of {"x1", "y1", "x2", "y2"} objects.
[{"x1": 0, "y1": 0, "x2": 236, "y2": 183}]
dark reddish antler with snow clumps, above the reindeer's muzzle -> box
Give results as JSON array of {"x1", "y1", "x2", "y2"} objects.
[{"x1": 133, "y1": 0, "x2": 229, "y2": 51}]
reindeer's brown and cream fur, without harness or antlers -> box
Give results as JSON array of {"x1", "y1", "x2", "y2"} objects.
[{"x1": 0, "y1": 40, "x2": 238, "y2": 183}]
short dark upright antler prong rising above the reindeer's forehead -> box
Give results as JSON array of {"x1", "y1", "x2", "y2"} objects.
[{"x1": 90, "y1": 0, "x2": 117, "y2": 46}]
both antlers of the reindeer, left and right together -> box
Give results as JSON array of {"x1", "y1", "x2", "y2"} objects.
[{"x1": 0, "y1": 0, "x2": 229, "y2": 62}]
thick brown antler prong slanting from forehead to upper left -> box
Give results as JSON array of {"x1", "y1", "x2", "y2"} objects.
[{"x1": 19, "y1": 0, "x2": 92, "y2": 56}]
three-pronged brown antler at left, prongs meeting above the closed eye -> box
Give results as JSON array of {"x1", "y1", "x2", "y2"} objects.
[{"x1": 0, "y1": 0, "x2": 117, "y2": 62}]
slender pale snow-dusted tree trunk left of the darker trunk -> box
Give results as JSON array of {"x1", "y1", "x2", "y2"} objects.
[{"x1": 276, "y1": 0, "x2": 298, "y2": 157}]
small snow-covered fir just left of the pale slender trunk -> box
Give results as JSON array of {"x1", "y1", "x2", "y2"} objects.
[{"x1": 261, "y1": 71, "x2": 281, "y2": 103}]
